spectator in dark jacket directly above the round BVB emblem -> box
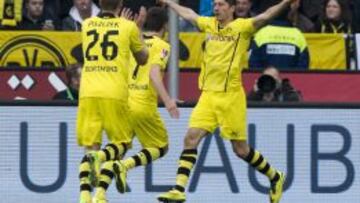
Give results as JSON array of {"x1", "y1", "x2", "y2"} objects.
[{"x1": 17, "y1": 0, "x2": 58, "y2": 30}]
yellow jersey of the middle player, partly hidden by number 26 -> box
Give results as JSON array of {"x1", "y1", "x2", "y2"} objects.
[{"x1": 129, "y1": 36, "x2": 170, "y2": 107}]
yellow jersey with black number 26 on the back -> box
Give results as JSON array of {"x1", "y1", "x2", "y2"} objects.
[{"x1": 80, "y1": 13, "x2": 144, "y2": 102}]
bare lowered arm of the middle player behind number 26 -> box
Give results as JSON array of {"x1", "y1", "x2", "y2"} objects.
[{"x1": 150, "y1": 64, "x2": 180, "y2": 118}]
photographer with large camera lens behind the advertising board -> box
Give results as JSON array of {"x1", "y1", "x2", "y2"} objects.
[{"x1": 247, "y1": 67, "x2": 302, "y2": 102}]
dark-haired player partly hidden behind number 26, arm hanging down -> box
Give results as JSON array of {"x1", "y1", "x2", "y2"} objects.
[{"x1": 90, "y1": 7, "x2": 179, "y2": 203}]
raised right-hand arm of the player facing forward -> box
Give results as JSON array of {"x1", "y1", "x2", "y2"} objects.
[{"x1": 254, "y1": 0, "x2": 297, "y2": 30}]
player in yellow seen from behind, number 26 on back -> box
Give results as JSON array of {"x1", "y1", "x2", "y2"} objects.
[{"x1": 76, "y1": 0, "x2": 148, "y2": 203}]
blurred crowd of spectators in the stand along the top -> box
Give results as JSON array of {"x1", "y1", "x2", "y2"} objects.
[{"x1": 0, "y1": 0, "x2": 360, "y2": 34}]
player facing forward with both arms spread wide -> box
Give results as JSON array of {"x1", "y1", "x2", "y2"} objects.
[{"x1": 158, "y1": 0, "x2": 294, "y2": 203}]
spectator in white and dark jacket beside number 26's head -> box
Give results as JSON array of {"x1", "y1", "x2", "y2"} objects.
[{"x1": 62, "y1": 0, "x2": 100, "y2": 31}]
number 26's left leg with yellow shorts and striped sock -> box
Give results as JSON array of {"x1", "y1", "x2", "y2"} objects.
[{"x1": 77, "y1": 99, "x2": 102, "y2": 203}]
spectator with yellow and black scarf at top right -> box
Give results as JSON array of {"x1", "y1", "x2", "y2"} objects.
[{"x1": 315, "y1": 0, "x2": 352, "y2": 34}]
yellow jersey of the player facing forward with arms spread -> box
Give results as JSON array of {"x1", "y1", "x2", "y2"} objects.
[{"x1": 196, "y1": 17, "x2": 255, "y2": 92}]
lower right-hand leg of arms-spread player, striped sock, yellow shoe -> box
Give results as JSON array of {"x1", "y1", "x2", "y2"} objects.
[{"x1": 231, "y1": 140, "x2": 285, "y2": 203}]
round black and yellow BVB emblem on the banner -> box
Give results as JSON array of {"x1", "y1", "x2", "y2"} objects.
[{"x1": 0, "y1": 35, "x2": 68, "y2": 68}]
